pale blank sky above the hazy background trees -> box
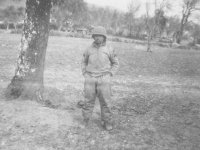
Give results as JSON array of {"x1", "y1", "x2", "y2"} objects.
[{"x1": 85, "y1": 0, "x2": 181, "y2": 15}]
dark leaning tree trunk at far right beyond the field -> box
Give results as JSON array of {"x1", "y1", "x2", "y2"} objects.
[{"x1": 176, "y1": 0, "x2": 200, "y2": 44}]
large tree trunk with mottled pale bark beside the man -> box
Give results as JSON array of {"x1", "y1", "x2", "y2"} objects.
[{"x1": 5, "y1": 0, "x2": 51, "y2": 100}]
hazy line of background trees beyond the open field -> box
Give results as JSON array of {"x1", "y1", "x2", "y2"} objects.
[{"x1": 0, "y1": 0, "x2": 200, "y2": 43}]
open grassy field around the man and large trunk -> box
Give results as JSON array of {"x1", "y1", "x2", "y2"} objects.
[{"x1": 0, "y1": 34, "x2": 200, "y2": 150}]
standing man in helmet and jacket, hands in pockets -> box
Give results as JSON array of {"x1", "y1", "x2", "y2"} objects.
[{"x1": 81, "y1": 26, "x2": 119, "y2": 130}]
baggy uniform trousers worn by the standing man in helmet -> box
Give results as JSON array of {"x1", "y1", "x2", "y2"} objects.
[{"x1": 82, "y1": 74, "x2": 111, "y2": 122}]
